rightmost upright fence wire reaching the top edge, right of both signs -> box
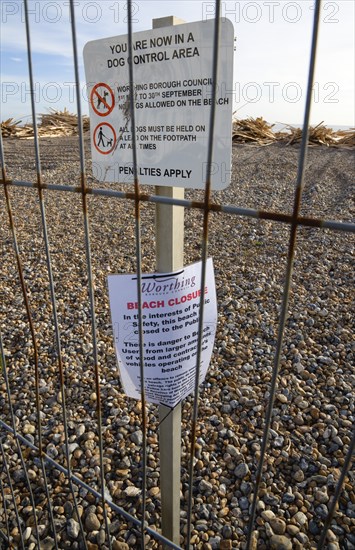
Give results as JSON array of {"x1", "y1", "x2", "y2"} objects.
[{"x1": 247, "y1": 0, "x2": 321, "y2": 550}]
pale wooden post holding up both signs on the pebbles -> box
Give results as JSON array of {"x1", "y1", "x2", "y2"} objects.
[{"x1": 153, "y1": 16, "x2": 185, "y2": 545}]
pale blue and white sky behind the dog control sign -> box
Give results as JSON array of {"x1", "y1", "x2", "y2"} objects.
[{"x1": 0, "y1": 0, "x2": 355, "y2": 127}]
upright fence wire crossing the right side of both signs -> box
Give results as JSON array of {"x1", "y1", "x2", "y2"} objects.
[{"x1": 186, "y1": 0, "x2": 221, "y2": 549}]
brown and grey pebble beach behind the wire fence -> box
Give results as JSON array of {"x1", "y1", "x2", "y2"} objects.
[{"x1": 0, "y1": 137, "x2": 355, "y2": 550}]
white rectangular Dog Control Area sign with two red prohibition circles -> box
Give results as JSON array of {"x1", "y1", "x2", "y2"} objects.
[{"x1": 84, "y1": 19, "x2": 234, "y2": 190}]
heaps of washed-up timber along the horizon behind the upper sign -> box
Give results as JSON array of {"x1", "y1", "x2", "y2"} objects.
[{"x1": 1, "y1": 109, "x2": 355, "y2": 147}]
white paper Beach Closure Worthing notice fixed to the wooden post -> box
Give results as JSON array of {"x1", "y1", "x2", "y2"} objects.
[{"x1": 108, "y1": 258, "x2": 217, "y2": 407}]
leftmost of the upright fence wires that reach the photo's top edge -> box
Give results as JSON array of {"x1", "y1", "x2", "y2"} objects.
[{"x1": 24, "y1": 0, "x2": 87, "y2": 549}]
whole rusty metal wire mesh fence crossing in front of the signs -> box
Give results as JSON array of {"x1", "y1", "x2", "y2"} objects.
[{"x1": 0, "y1": 0, "x2": 355, "y2": 550}]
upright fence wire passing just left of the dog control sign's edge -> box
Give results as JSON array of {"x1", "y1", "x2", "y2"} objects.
[{"x1": 69, "y1": 0, "x2": 112, "y2": 550}]
